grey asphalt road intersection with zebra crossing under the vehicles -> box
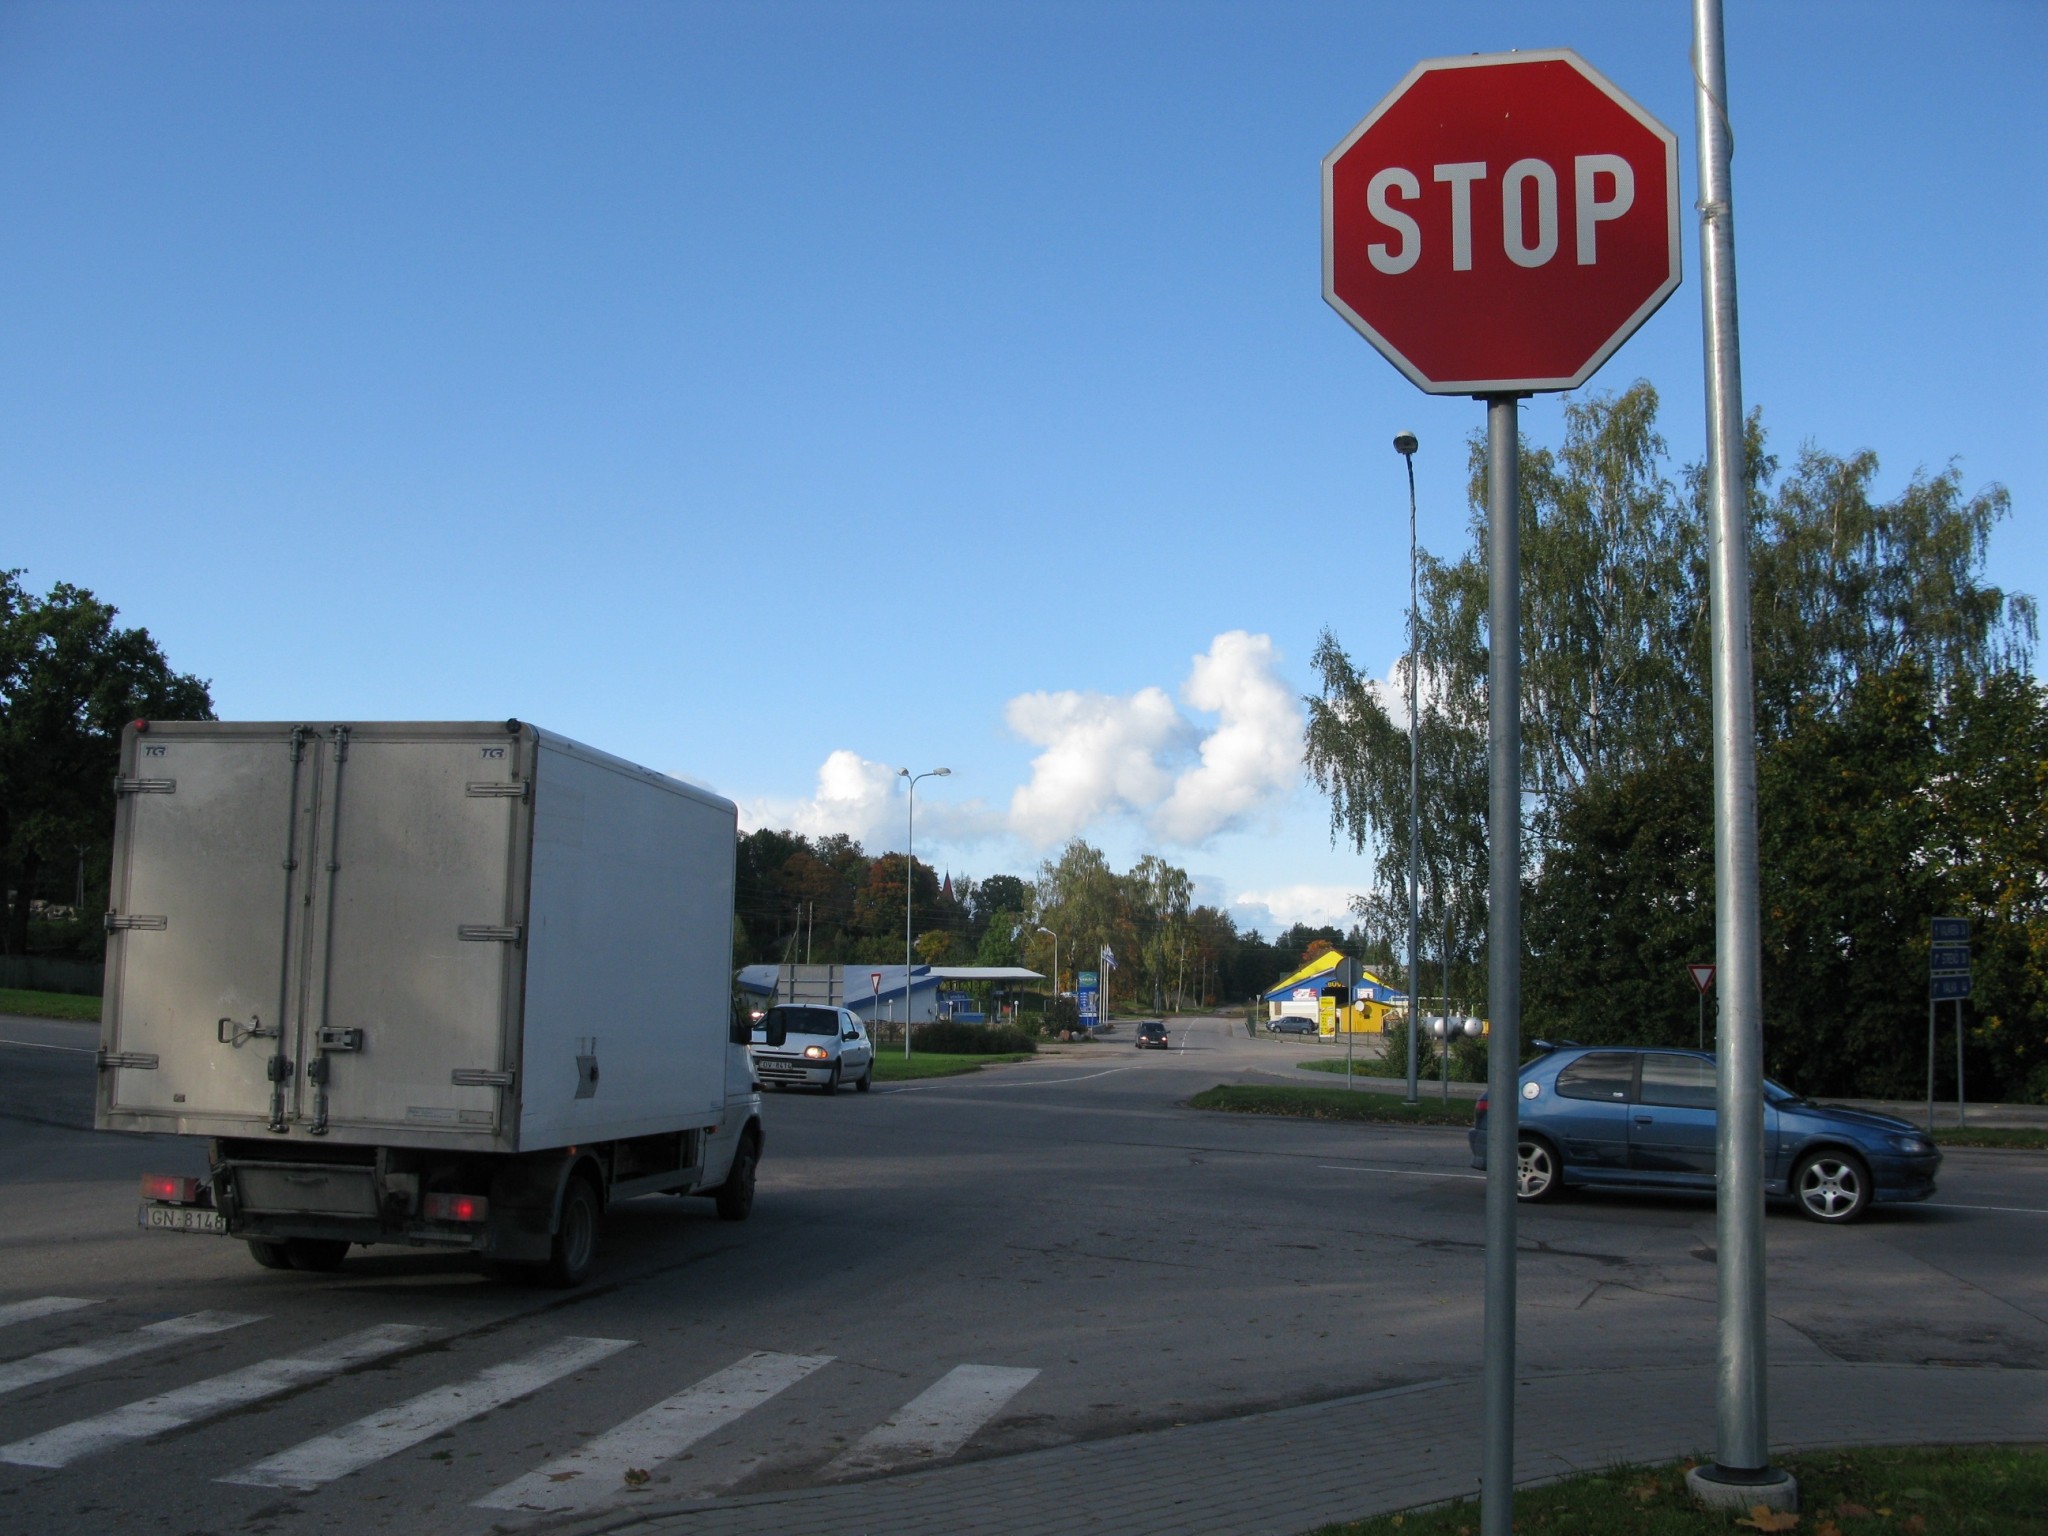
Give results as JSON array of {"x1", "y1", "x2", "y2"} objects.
[{"x1": 0, "y1": 1020, "x2": 2048, "y2": 1536}]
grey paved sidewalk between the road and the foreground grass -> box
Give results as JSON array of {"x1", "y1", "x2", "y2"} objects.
[{"x1": 545, "y1": 1362, "x2": 2048, "y2": 1536}]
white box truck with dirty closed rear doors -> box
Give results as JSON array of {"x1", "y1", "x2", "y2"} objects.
[{"x1": 96, "y1": 721, "x2": 762, "y2": 1284}]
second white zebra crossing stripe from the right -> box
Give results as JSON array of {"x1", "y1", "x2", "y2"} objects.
[{"x1": 475, "y1": 1350, "x2": 831, "y2": 1513}]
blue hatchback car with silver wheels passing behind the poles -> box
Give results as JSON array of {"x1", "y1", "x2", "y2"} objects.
[{"x1": 1468, "y1": 1040, "x2": 1942, "y2": 1223}]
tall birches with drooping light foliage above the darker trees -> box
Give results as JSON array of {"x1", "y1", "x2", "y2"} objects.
[{"x1": 1307, "y1": 383, "x2": 2036, "y2": 1036}]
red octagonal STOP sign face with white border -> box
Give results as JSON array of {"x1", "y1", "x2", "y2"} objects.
[{"x1": 1323, "y1": 49, "x2": 1679, "y2": 395}]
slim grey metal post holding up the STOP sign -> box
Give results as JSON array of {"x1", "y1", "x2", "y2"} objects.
[{"x1": 1479, "y1": 395, "x2": 1522, "y2": 1536}]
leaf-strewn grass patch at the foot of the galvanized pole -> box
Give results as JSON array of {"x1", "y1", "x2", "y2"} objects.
[{"x1": 1317, "y1": 1446, "x2": 2048, "y2": 1536}]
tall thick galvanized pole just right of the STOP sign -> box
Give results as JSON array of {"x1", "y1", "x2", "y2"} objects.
[{"x1": 1692, "y1": 0, "x2": 1786, "y2": 1485}]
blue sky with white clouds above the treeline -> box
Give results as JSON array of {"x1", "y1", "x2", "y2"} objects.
[{"x1": 0, "y1": 0, "x2": 2048, "y2": 928}]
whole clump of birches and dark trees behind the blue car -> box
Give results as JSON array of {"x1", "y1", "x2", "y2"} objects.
[{"x1": 1307, "y1": 383, "x2": 2048, "y2": 1092}]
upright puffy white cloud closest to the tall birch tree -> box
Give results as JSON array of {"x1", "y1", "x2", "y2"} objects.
[{"x1": 1151, "y1": 629, "x2": 1303, "y2": 844}]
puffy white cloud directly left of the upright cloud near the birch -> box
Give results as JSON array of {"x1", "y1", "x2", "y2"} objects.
[{"x1": 1004, "y1": 688, "x2": 1192, "y2": 848}]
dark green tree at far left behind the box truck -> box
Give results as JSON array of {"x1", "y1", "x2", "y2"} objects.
[{"x1": 0, "y1": 571, "x2": 213, "y2": 954}]
